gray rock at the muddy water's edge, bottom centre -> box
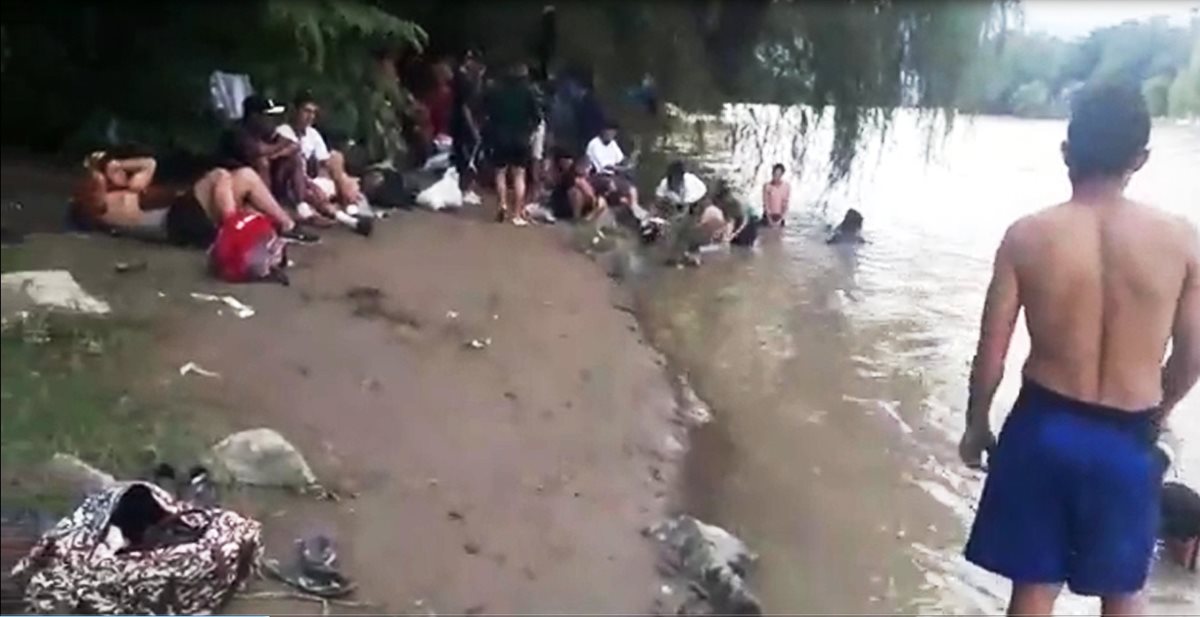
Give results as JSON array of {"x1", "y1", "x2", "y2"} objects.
[{"x1": 646, "y1": 515, "x2": 762, "y2": 615}]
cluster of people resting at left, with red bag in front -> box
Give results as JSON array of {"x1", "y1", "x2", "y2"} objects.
[{"x1": 71, "y1": 88, "x2": 393, "y2": 280}]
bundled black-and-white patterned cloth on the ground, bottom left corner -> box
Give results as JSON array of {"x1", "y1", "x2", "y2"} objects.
[{"x1": 12, "y1": 481, "x2": 263, "y2": 615}]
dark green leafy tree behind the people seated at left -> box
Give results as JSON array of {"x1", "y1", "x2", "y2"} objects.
[{"x1": 2, "y1": 0, "x2": 426, "y2": 158}]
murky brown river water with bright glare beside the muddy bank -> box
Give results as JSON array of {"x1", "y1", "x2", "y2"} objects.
[{"x1": 640, "y1": 106, "x2": 1200, "y2": 615}]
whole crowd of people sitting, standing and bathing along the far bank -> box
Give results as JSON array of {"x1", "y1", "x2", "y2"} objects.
[{"x1": 71, "y1": 42, "x2": 862, "y2": 278}]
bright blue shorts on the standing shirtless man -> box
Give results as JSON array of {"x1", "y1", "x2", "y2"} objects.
[{"x1": 966, "y1": 379, "x2": 1163, "y2": 595}]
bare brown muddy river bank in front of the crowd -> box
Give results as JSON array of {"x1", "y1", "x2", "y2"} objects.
[{"x1": 2, "y1": 160, "x2": 680, "y2": 613}]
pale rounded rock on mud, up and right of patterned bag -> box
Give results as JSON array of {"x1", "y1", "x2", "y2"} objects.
[{"x1": 206, "y1": 429, "x2": 317, "y2": 489}]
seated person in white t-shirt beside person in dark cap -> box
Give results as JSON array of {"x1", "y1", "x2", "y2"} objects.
[{"x1": 275, "y1": 92, "x2": 374, "y2": 235}]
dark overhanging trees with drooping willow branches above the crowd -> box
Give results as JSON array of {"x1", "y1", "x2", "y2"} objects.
[{"x1": 0, "y1": 0, "x2": 1010, "y2": 180}]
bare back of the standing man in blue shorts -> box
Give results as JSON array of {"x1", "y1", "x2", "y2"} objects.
[{"x1": 1002, "y1": 194, "x2": 1200, "y2": 411}]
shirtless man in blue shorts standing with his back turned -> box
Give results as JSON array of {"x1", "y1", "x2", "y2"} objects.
[{"x1": 959, "y1": 86, "x2": 1200, "y2": 615}]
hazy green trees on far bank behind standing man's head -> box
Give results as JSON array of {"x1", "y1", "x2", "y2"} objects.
[{"x1": 958, "y1": 17, "x2": 1200, "y2": 118}]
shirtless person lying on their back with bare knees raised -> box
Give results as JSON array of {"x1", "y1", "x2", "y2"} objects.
[{"x1": 71, "y1": 152, "x2": 317, "y2": 248}]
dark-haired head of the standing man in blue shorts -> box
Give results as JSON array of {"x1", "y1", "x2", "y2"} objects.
[{"x1": 1066, "y1": 84, "x2": 1150, "y2": 181}]
